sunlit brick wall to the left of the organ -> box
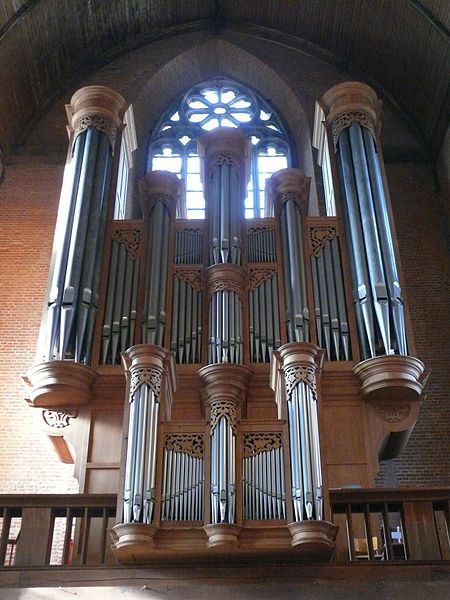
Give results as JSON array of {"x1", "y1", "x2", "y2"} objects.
[{"x1": 0, "y1": 159, "x2": 78, "y2": 493}]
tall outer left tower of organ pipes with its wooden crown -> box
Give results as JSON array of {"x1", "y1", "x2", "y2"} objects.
[{"x1": 44, "y1": 86, "x2": 126, "y2": 363}]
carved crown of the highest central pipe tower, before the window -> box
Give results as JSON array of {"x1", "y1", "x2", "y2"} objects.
[{"x1": 198, "y1": 128, "x2": 250, "y2": 186}]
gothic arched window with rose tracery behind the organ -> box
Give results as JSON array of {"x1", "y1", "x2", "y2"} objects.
[{"x1": 149, "y1": 79, "x2": 290, "y2": 219}]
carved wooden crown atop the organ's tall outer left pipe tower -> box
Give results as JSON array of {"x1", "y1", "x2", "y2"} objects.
[{"x1": 66, "y1": 85, "x2": 127, "y2": 154}]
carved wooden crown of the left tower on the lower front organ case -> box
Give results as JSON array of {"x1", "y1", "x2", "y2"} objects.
[{"x1": 122, "y1": 344, "x2": 176, "y2": 411}]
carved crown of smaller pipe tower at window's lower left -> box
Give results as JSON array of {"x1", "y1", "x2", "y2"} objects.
[{"x1": 139, "y1": 171, "x2": 180, "y2": 218}]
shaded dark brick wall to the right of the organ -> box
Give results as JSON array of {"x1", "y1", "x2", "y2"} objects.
[{"x1": 379, "y1": 164, "x2": 450, "y2": 486}]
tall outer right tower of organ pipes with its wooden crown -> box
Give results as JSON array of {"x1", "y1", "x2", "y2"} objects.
[{"x1": 321, "y1": 82, "x2": 408, "y2": 358}]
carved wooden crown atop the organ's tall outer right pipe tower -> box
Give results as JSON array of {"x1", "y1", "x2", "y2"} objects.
[{"x1": 316, "y1": 81, "x2": 381, "y2": 147}]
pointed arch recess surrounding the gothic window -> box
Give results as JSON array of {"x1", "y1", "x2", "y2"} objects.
[{"x1": 133, "y1": 39, "x2": 318, "y2": 214}]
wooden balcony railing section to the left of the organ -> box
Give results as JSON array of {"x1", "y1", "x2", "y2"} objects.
[{"x1": 0, "y1": 494, "x2": 117, "y2": 567}]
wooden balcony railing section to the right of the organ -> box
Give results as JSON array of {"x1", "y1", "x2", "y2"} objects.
[{"x1": 330, "y1": 488, "x2": 450, "y2": 561}]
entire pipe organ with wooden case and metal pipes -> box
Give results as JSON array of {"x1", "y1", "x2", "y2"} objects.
[{"x1": 24, "y1": 84, "x2": 423, "y2": 562}]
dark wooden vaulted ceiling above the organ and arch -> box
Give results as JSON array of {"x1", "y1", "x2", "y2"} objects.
[{"x1": 0, "y1": 0, "x2": 450, "y2": 159}]
